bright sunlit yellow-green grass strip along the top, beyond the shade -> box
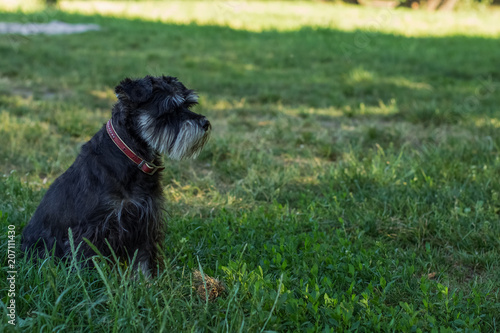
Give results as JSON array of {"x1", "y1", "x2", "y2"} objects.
[{"x1": 0, "y1": 0, "x2": 500, "y2": 36}]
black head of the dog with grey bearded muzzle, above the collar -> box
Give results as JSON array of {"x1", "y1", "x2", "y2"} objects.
[{"x1": 115, "y1": 76, "x2": 211, "y2": 160}]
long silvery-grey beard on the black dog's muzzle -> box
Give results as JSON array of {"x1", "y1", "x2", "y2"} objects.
[{"x1": 140, "y1": 115, "x2": 210, "y2": 160}]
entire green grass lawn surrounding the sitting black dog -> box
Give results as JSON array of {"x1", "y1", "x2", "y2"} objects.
[{"x1": 0, "y1": 2, "x2": 500, "y2": 332}]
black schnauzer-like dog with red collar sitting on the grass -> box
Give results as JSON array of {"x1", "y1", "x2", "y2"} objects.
[{"x1": 21, "y1": 76, "x2": 211, "y2": 274}]
